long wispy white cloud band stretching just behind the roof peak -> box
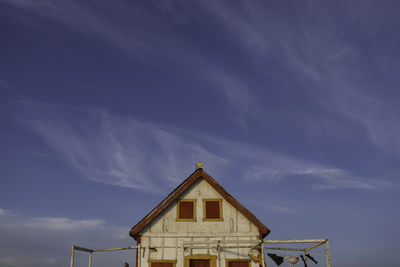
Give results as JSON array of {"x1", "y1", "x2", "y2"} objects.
[{"x1": 18, "y1": 100, "x2": 390, "y2": 192}]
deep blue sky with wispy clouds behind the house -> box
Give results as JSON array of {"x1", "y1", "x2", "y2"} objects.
[{"x1": 0, "y1": 0, "x2": 400, "y2": 267}]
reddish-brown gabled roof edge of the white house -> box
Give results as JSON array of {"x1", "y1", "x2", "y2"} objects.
[{"x1": 129, "y1": 169, "x2": 270, "y2": 239}]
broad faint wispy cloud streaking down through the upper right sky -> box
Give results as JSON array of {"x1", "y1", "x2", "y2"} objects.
[{"x1": 191, "y1": 1, "x2": 400, "y2": 159}]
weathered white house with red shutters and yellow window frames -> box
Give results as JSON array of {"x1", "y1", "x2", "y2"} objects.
[{"x1": 129, "y1": 163, "x2": 270, "y2": 267}]
